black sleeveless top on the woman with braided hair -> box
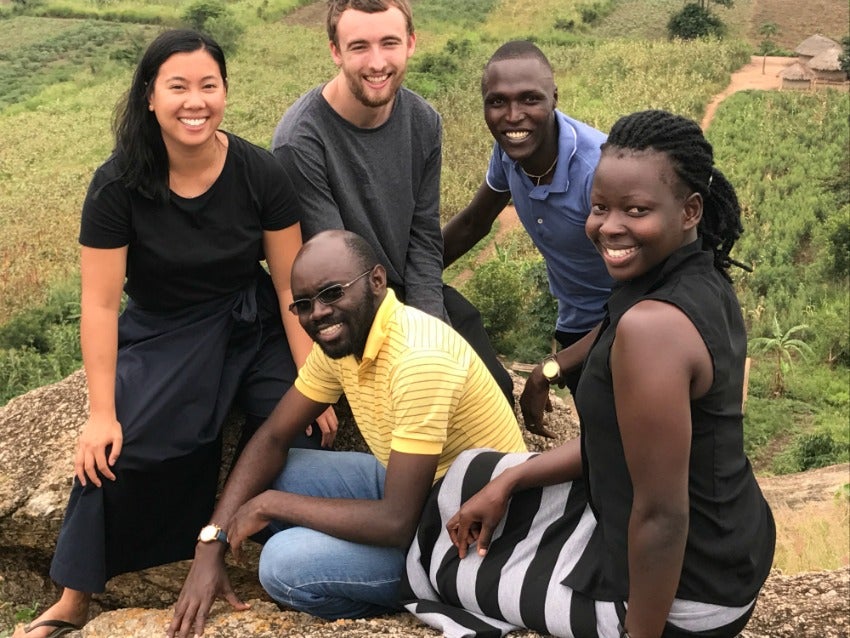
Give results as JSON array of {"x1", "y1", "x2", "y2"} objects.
[{"x1": 564, "y1": 240, "x2": 775, "y2": 606}]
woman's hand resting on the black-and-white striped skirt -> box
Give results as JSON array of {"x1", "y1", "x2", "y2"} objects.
[{"x1": 446, "y1": 477, "x2": 511, "y2": 558}]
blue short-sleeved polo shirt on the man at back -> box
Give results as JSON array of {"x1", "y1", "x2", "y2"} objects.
[{"x1": 487, "y1": 111, "x2": 614, "y2": 332}]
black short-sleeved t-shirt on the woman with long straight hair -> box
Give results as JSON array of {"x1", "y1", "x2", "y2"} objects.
[{"x1": 80, "y1": 133, "x2": 301, "y2": 310}]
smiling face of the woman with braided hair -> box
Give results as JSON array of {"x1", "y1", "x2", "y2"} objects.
[{"x1": 585, "y1": 147, "x2": 702, "y2": 281}]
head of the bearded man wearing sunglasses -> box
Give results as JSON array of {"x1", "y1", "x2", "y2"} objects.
[{"x1": 292, "y1": 235, "x2": 386, "y2": 359}]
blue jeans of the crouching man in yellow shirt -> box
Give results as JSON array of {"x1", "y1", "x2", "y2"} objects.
[{"x1": 259, "y1": 449, "x2": 406, "y2": 620}]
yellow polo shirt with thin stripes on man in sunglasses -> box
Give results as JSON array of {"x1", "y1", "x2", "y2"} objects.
[{"x1": 295, "y1": 290, "x2": 526, "y2": 480}]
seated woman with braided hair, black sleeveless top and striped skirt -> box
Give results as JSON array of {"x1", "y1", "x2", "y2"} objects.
[{"x1": 406, "y1": 111, "x2": 775, "y2": 638}]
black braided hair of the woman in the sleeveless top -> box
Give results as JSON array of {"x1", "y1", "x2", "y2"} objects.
[{"x1": 602, "y1": 110, "x2": 750, "y2": 279}]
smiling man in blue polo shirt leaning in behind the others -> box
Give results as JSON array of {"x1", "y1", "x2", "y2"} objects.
[{"x1": 443, "y1": 41, "x2": 612, "y2": 434}]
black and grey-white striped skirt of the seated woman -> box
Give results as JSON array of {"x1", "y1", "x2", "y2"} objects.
[{"x1": 402, "y1": 450, "x2": 753, "y2": 638}]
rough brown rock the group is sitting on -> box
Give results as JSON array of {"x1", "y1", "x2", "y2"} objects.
[{"x1": 0, "y1": 372, "x2": 850, "y2": 638}]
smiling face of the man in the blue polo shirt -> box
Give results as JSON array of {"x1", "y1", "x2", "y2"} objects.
[{"x1": 482, "y1": 57, "x2": 558, "y2": 172}]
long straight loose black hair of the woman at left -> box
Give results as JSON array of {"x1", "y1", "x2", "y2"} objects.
[{"x1": 112, "y1": 29, "x2": 227, "y2": 201}]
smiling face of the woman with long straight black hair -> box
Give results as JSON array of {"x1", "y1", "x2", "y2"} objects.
[{"x1": 148, "y1": 49, "x2": 227, "y2": 151}]
